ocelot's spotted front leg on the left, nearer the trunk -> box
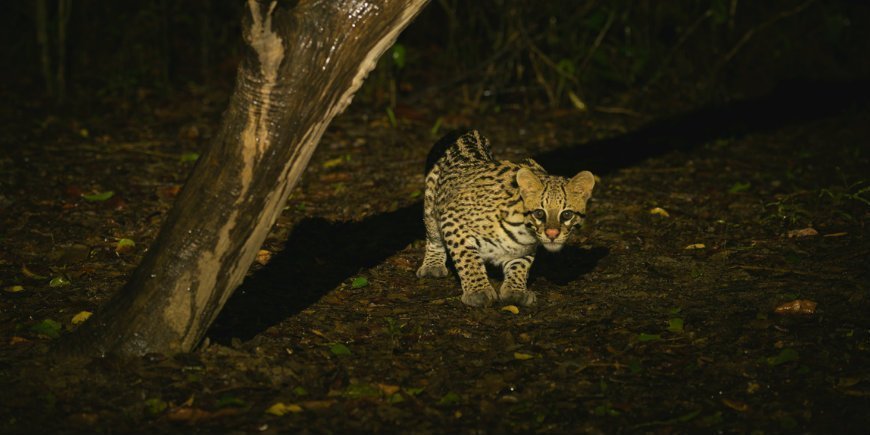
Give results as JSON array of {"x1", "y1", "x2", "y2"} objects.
[{"x1": 446, "y1": 235, "x2": 496, "y2": 307}]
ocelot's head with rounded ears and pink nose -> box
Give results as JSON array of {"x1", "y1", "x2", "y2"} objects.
[{"x1": 517, "y1": 168, "x2": 595, "y2": 252}]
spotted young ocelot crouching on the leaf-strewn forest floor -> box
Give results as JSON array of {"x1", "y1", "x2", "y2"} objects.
[{"x1": 417, "y1": 130, "x2": 595, "y2": 307}]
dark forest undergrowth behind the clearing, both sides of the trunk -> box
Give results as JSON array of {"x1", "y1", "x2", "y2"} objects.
[{"x1": 0, "y1": 0, "x2": 870, "y2": 115}]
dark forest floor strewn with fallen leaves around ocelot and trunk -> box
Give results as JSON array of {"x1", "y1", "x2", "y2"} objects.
[{"x1": 0, "y1": 81, "x2": 870, "y2": 434}]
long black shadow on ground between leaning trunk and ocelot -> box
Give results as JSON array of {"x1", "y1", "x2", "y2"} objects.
[{"x1": 208, "y1": 202, "x2": 423, "y2": 343}]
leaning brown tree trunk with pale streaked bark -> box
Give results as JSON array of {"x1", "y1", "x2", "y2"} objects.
[{"x1": 61, "y1": 0, "x2": 427, "y2": 356}]
